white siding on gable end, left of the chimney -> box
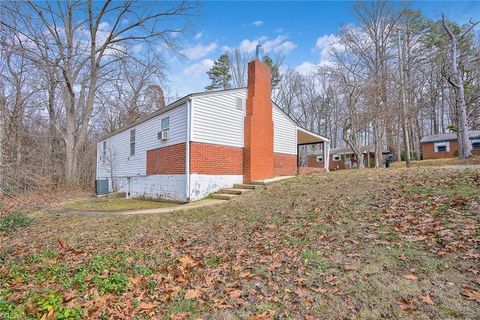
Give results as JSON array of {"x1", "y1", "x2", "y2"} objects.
[{"x1": 191, "y1": 89, "x2": 247, "y2": 148}]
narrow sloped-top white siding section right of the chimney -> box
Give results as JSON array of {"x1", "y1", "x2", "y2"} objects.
[{"x1": 272, "y1": 104, "x2": 297, "y2": 154}]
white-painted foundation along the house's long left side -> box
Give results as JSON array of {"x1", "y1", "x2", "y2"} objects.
[{"x1": 103, "y1": 174, "x2": 187, "y2": 202}]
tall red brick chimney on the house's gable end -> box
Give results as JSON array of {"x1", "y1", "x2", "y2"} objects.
[{"x1": 243, "y1": 56, "x2": 273, "y2": 182}]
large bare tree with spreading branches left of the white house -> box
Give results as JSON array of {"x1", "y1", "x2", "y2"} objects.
[{"x1": 1, "y1": 0, "x2": 197, "y2": 183}]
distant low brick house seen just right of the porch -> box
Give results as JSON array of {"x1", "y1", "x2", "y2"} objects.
[{"x1": 308, "y1": 145, "x2": 389, "y2": 170}]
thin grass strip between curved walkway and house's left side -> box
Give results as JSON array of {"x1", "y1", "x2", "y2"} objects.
[{"x1": 59, "y1": 197, "x2": 178, "y2": 211}]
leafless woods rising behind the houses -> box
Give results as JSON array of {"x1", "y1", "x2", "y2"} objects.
[{"x1": 0, "y1": 1, "x2": 480, "y2": 194}]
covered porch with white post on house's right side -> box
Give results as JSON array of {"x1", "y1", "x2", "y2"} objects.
[{"x1": 297, "y1": 127, "x2": 330, "y2": 174}]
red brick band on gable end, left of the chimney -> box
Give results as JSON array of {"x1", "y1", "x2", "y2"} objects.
[{"x1": 190, "y1": 142, "x2": 243, "y2": 175}]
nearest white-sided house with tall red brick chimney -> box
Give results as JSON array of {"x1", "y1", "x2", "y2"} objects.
[{"x1": 96, "y1": 60, "x2": 329, "y2": 201}]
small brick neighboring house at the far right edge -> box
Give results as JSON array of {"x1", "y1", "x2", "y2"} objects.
[{"x1": 420, "y1": 130, "x2": 480, "y2": 159}]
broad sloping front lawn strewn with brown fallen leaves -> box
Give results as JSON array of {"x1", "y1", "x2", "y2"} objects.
[{"x1": 0, "y1": 167, "x2": 480, "y2": 320}]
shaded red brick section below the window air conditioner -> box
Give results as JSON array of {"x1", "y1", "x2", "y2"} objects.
[{"x1": 147, "y1": 143, "x2": 185, "y2": 175}]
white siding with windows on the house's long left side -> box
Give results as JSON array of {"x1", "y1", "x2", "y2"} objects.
[{"x1": 97, "y1": 104, "x2": 187, "y2": 179}]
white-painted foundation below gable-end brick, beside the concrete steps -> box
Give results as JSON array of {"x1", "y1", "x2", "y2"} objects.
[{"x1": 190, "y1": 174, "x2": 243, "y2": 201}]
